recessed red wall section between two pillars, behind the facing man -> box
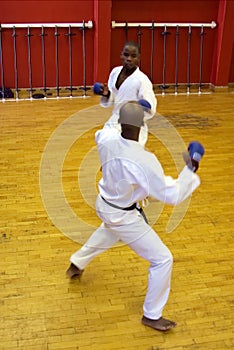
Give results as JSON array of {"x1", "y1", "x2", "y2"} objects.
[{"x1": 111, "y1": 0, "x2": 219, "y2": 84}]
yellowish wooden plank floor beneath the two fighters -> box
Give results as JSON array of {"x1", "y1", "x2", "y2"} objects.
[{"x1": 0, "y1": 92, "x2": 234, "y2": 350}]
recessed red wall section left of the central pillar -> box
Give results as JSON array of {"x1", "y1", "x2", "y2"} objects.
[{"x1": 0, "y1": 0, "x2": 93, "y2": 88}]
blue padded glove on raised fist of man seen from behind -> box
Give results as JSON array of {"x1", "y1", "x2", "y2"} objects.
[{"x1": 183, "y1": 141, "x2": 205, "y2": 173}]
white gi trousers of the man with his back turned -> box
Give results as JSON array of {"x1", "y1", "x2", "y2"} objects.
[{"x1": 70, "y1": 196, "x2": 173, "y2": 320}]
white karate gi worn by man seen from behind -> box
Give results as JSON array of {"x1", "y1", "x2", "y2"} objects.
[{"x1": 70, "y1": 128, "x2": 200, "y2": 319}]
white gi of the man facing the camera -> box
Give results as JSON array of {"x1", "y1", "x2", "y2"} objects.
[{"x1": 100, "y1": 66, "x2": 157, "y2": 146}]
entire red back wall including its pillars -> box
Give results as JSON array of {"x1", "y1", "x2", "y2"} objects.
[{"x1": 0, "y1": 0, "x2": 234, "y2": 88}]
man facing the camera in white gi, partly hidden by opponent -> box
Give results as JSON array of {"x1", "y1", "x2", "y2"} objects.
[{"x1": 94, "y1": 41, "x2": 157, "y2": 145}]
